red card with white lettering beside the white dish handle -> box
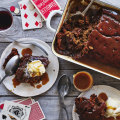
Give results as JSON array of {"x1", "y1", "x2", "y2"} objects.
[{"x1": 30, "y1": 0, "x2": 61, "y2": 20}]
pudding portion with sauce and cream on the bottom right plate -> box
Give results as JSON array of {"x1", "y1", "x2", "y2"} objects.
[{"x1": 75, "y1": 93, "x2": 120, "y2": 120}]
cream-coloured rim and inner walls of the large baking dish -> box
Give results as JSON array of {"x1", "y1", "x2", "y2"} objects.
[{"x1": 52, "y1": 0, "x2": 120, "y2": 80}]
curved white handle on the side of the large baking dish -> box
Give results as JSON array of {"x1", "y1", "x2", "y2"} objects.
[{"x1": 46, "y1": 10, "x2": 63, "y2": 32}]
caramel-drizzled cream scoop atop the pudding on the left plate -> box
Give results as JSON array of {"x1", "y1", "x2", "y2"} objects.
[{"x1": 27, "y1": 60, "x2": 45, "y2": 77}]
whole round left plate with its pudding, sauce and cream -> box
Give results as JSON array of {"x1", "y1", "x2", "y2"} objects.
[{"x1": 0, "y1": 38, "x2": 59, "y2": 97}]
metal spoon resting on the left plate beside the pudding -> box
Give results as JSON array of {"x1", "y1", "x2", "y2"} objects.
[{"x1": 0, "y1": 55, "x2": 20, "y2": 84}]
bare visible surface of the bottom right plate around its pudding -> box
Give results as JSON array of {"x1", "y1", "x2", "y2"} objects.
[{"x1": 72, "y1": 85, "x2": 120, "y2": 120}]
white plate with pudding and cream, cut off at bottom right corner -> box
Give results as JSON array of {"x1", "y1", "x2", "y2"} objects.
[{"x1": 72, "y1": 85, "x2": 120, "y2": 120}]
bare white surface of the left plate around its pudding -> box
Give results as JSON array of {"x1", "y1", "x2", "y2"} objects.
[{"x1": 0, "y1": 38, "x2": 59, "y2": 97}]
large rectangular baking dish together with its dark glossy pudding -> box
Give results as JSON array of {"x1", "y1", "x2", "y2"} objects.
[{"x1": 52, "y1": 0, "x2": 120, "y2": 79}]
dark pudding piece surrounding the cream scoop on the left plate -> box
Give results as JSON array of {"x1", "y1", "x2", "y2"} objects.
[{"x1": 15, "y1": 54, "x2": 49, "y2": 85}]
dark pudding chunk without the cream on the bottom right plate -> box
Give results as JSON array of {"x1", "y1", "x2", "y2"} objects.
[{"x1": 75, "y1": 94, "x2": 106, "y2": 120}]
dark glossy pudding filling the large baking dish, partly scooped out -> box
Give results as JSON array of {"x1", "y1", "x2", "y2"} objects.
[{"x1": 54, "y1": 0, "x2": 120, "y2": 77}]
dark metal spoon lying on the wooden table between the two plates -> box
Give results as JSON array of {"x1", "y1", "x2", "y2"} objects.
[{"x1": 57, "y1": 75, "x2": 71, "y2": 120}]
